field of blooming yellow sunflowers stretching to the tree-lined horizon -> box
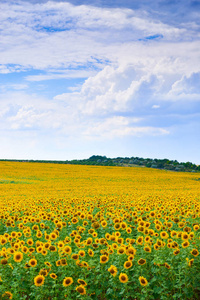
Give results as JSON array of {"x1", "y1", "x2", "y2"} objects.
[{"x1": 0, "y1": 161, "x2": 200, "y2": 300}]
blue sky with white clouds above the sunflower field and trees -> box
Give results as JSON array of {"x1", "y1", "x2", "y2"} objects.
[{"x1": 0, "y1": 0, "x2": 200, "y2": 164}]
